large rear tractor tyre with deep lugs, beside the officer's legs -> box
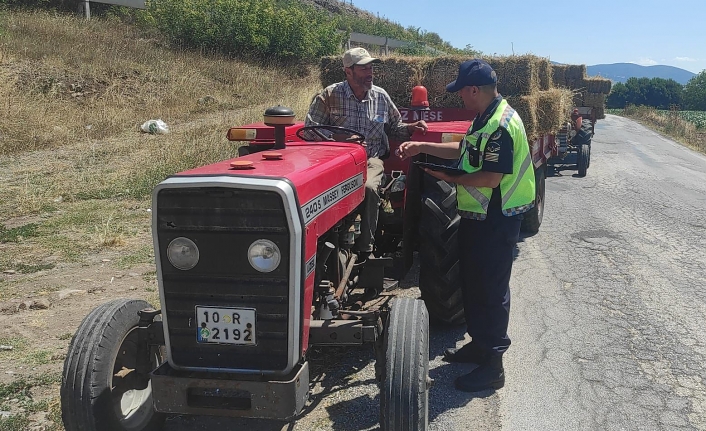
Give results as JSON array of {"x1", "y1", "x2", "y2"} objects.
[{"x1": 419, "y1": 174, "x2": 465, "y2": 324}]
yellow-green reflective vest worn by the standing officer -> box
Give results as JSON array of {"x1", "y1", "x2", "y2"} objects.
[{"x1": 456, "y1": 99, "x2": 535, "y2": 220}]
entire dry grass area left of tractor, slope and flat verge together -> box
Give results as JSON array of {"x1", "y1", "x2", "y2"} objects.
[{"x1": 0, "y1": 12, "x2": 320, "y2": 271}]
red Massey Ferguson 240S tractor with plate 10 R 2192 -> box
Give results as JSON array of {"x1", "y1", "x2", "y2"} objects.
[{"x1": 61, "y1": 90, "x2": 553, "y2": 431}]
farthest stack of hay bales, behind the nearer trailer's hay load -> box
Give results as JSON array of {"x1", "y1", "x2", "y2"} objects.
[{"x1": 551, "y1": 64, "x2": 611, "y2": 119}]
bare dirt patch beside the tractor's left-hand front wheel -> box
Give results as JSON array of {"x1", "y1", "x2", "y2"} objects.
[{"x1": 0, "y1": 257, "x2": 159, "y2": 372}]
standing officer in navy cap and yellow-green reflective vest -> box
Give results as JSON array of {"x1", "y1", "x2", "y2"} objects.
[{"x1": 400, "y1": 59, "x2": 535, "y2": 392}]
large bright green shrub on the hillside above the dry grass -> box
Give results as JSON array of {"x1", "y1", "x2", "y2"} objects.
[{"x1": 148, "y1": 0, "x2": 344, "y2": 62}]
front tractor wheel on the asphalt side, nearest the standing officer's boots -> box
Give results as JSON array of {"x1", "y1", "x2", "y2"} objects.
[{"x1": 380, "y1": 298, "x2": 431, "y2": 431}]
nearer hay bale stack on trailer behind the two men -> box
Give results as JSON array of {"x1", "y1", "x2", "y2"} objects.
[{"x1": 321, "y1": 55, "x2": 573, "y2": 140}]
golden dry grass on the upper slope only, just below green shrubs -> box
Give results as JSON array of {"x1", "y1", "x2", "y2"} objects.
[{"x1": 0, "y1": 8, "x2": 312, "y2": 153}]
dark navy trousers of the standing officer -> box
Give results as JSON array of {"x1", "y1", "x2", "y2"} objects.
[{"x1": 458, "y1": 213, "x2": 522, "y2": 355}]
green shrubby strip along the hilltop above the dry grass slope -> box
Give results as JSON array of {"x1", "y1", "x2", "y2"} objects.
[{"x1": 0, "y1": 0, "x2": 477, "y2": 62}]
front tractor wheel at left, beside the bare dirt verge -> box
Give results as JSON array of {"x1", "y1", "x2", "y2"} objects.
[{"x1": 60, "y1": 299, "x2": 166, "y2": 431}]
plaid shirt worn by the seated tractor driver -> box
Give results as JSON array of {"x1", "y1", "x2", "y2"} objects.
[{"x1": 305, "y1": 81, "x2": 410, "y2": 157}]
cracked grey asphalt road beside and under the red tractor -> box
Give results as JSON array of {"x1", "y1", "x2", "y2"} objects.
[{"x1": 167, "y1": 116, "x2": 706, "y2": 431}]
